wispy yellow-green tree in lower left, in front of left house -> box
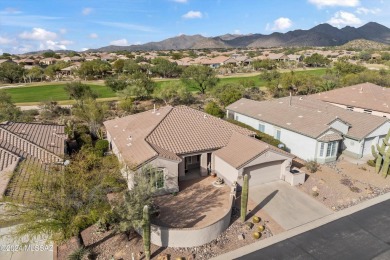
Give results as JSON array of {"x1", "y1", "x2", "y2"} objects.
[{"x1": 0, "y1": 148, "x2": 126, "y2": 242}]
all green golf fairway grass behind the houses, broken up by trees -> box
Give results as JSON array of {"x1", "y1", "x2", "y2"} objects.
[{"x1": 5, "y1": 69, "x2": 326, "y2": 105}]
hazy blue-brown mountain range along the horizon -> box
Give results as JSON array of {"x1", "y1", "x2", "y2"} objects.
[{"x1": 88, "y1": 22, "x2": 390, "y2": 52}]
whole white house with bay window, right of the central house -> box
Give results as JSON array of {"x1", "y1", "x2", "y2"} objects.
[{"x1": 226, "y1": 97, "x2": 390, "y2": 163}]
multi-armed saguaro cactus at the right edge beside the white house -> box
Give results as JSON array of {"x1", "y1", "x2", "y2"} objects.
[{"x1": 371, "y1": 130, "x2": 390, "y2": 177}]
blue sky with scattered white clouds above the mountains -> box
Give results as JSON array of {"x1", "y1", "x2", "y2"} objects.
[{"x1": 0, "y1": 0, "x2": 390, "y2": 53}]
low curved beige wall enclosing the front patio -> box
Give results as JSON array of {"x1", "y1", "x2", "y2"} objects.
[{"x1": 151, "y1": 191, "x2": 235, "y2": 247}]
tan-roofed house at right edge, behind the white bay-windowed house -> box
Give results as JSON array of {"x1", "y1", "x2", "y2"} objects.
[{"x1": 310, "y1": 83, "x2": 390, "y2": 118}]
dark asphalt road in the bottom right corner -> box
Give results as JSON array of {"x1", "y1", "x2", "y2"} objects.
[{"x1": 236, "y1": 200, "x2": 390, "y2": 260}]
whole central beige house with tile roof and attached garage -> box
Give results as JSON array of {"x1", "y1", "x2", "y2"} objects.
[{"x1": 104, "y1": 106, "x2": 294, "y2": 194}]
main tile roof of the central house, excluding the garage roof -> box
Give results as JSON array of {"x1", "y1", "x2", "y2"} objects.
[{"x1": 104, "y1": 106, "x2": 255, "y2": 166}]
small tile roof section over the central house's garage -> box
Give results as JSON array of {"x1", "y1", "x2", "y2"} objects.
[{"x1": 214, "y1": 133, "x2": 295, "y2": 169}]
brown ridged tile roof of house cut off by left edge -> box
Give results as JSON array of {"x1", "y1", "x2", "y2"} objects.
[{"x1": 0, "y1": 122, "x2": 66, "y2": 201}]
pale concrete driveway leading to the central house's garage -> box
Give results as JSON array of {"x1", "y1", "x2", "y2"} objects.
[{"x1": 249, "y1": 180, "x2": 333, "y2": 230}]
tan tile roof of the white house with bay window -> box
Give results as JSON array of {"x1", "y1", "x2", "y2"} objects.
[{"x1": 226, "y1": 96, "x2": 388, "y2": 140}]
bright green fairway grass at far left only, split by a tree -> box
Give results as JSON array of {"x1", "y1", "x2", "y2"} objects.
[{"x1": 5, "y1": 84, "x2": 115, "y2": 103}]
